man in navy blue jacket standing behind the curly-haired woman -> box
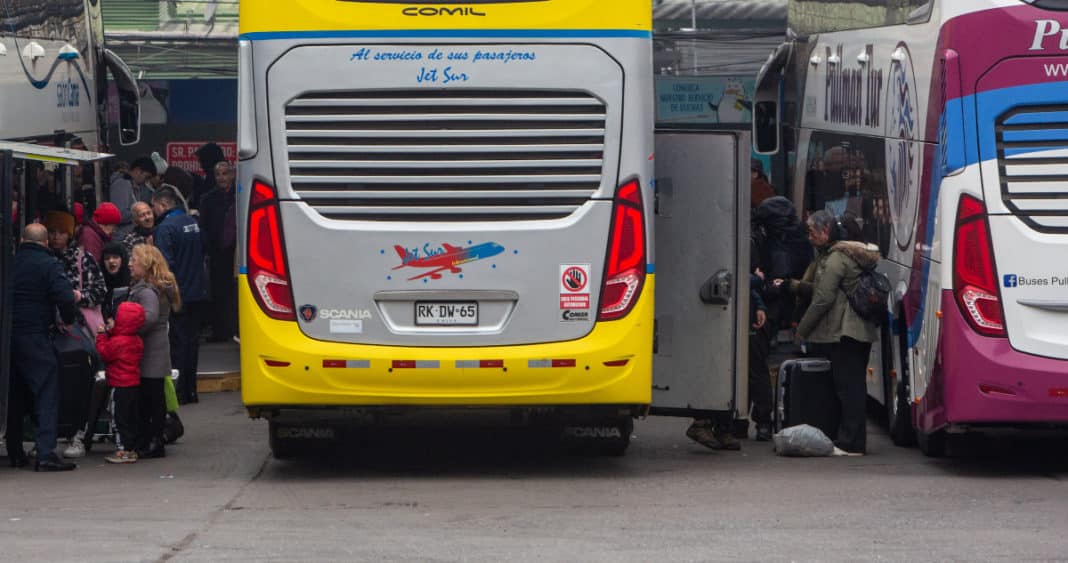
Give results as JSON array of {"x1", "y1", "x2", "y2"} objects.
[{"x1": 152, "y1": 188, "x2": 207, "y2": 403}]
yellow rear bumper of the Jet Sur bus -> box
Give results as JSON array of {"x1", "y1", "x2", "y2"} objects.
[{"x1": 238, "y1": 276, "x2": 655, "y2": 409}]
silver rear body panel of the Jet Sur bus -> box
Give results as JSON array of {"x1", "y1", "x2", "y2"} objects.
[{"x1": 238, "y1": 38, "x2": 655, "y2": 346}]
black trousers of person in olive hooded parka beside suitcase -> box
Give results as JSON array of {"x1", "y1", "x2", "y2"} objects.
[{"x1": 831, "y1": 337, "x2": 871, "y2": 453}]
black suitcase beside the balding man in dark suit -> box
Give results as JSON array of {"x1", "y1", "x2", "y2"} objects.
[{"x1": 52, "y1": 326, "x2": 99, "y2": 438}]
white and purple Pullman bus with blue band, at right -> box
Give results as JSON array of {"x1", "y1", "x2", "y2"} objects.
[{"x1": 754, "y1": 0, "x2": 1068, "y2": 454}]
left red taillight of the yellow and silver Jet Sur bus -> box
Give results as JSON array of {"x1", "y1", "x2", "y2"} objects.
[{"x1": 248, "y1": 181, "x2": 297, "y2": 320}]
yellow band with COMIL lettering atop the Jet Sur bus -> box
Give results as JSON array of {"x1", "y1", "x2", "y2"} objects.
[{"x1": 240, "y1": 0, "x2": 653, "y2": 34}]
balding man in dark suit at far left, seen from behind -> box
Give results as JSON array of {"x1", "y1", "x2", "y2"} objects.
[{"x1": 6, "y1": 224, "x2": 77, "y2": 471}]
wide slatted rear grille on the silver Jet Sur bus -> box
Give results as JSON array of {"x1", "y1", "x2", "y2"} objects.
[{"x1": 285, "y1": 90, "x2": 606, "y2": 221}]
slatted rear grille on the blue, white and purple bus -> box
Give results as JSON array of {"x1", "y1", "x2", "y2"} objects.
[{"x1": 995, "y1": 105, "x2": 1068, "y2": 234}]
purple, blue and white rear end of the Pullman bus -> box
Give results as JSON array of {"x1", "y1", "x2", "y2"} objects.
[{"x1": 916, "y1": 0, "x2": 1068, "y2": 450}]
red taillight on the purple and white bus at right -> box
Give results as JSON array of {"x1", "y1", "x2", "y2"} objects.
[{"x1": 953, "y1": 196, "x2": 1006, "y2": 337}]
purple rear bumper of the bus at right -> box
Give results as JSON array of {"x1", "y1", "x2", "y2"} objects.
[{"x1": 916, "y1": 292, "x2": 1068, "y2": 432}]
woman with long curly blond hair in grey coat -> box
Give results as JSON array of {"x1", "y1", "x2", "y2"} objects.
[{"x1": 127, "y1": 245, "x2": 182, "y2": 459}]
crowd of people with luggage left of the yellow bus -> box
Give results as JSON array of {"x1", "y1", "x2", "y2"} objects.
[{"x1": 5, "y1": 143, "x2": 237, "y2": 471}]
